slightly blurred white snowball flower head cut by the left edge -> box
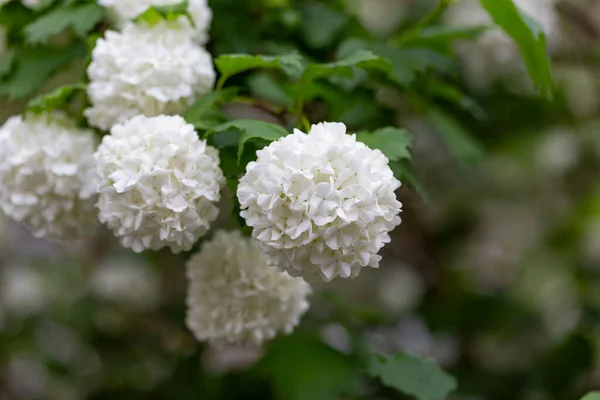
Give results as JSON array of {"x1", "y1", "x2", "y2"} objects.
[{"x1": 0, "y1": 111, "x2": 96, "y2": 240}]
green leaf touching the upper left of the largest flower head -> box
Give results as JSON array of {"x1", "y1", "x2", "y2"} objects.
[{"x1": 209, "y1": 119, "x2": 288, "y2": 164}]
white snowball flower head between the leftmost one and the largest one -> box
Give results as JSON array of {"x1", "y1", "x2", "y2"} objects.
[{"x1": 94, "y1": 115, "x2": 224, "y2": 253}]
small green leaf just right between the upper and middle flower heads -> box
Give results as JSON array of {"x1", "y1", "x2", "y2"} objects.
[{"x1": 183, "y1": 88, "x2": 237, "y2": 130}]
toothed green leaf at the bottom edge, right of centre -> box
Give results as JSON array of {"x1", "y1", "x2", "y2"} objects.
[{"x1": 368, "y1": 354, "x2": 456, "y2": 400}]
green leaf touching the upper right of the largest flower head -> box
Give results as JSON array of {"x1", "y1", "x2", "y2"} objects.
[{"x1": 356, "y1": 127, "x2": 412, "y2": 161}]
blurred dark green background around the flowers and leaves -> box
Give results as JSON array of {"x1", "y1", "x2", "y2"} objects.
[{"x1": 0, "y1": 0, "x2": 600, "y2": 400}]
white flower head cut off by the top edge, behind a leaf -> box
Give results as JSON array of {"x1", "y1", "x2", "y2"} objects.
[{"x1": 98, "y1": 0, "x2": 212, "y2": 44}]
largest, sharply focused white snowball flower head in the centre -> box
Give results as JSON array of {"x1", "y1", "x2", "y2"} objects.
[{"x1": 237, "y1": 123, "x2": 402, "y2": 281}]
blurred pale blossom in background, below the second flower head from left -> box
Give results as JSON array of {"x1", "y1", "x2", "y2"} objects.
[{"x1": 91, "y1": 258, "x2": 160, "y2": 310}]
